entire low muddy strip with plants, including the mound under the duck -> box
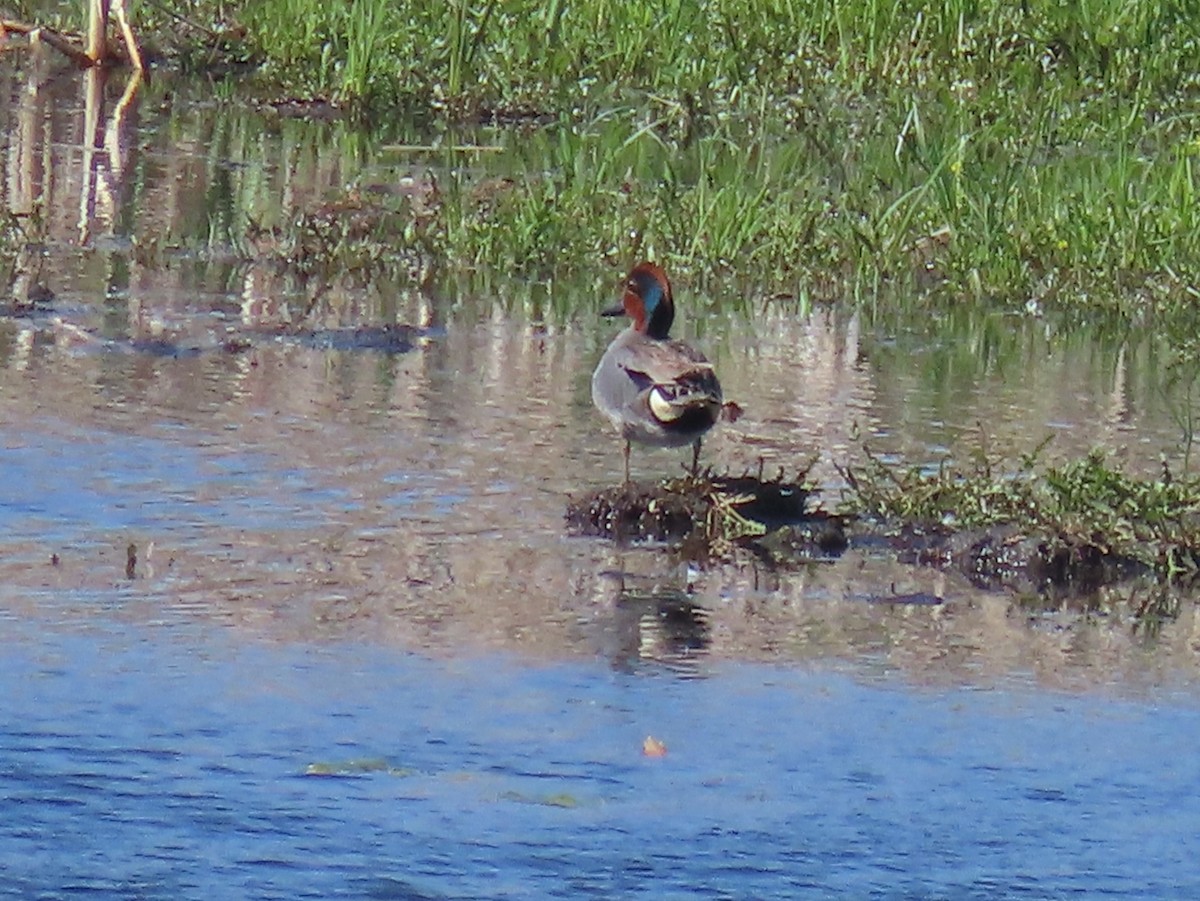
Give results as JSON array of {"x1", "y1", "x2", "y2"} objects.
[{"x1": 566, "y1": 448, "x2": 1200, "y2": 597}]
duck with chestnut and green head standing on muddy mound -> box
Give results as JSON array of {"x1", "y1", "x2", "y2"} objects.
[{"x1": 592, "y1": 262, "x2": 720, "y2": 485}]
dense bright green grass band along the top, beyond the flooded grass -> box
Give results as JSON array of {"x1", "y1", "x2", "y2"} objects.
[{"x1": 231, "y1": 0, "x2": 1200, "y2": 113}]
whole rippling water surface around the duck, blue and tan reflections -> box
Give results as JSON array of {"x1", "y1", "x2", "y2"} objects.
[{"x1": 0, "y1": 58, "x2": 1200, "y2": 897}]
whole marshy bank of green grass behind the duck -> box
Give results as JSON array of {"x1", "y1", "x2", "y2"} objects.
[{"x1": 14, "y1": 0, "x2": 1200, "y2": 314}]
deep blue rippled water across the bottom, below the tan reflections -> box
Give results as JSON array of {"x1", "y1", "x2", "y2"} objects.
[{"x1": 0, "y1": 620, "x2": 1200, "y2": 899}]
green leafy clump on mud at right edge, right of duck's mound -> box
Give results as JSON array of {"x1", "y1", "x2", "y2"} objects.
[{"x1": 842, "y1": 451, "x2": 1200, "y2": 583}]
